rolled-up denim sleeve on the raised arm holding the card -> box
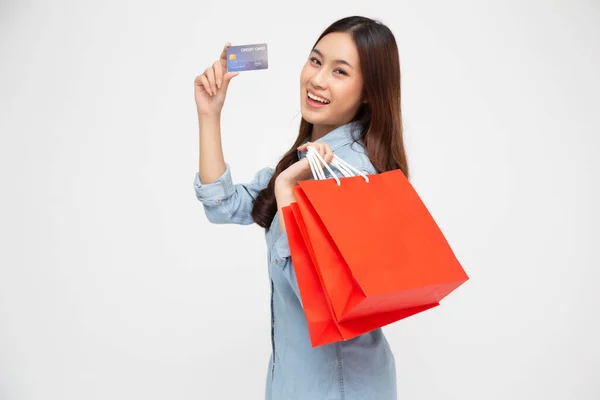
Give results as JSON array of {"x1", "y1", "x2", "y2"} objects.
[{"x1": 194, "y1": 164, "x2": 273, "y2": 225}]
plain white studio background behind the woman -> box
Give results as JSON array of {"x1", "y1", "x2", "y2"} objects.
[{"x1": 0, "y1": 0, "x2": 600, "y2": 400}]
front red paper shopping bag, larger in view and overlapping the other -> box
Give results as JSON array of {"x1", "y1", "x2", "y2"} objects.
[{"x1": 290, "y1": 170, "x2": 469, "y2": 325}]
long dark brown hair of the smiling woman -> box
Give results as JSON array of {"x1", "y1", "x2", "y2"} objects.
[{"x1": 251, "y1": 16, "x2": 408, "y2": 229}]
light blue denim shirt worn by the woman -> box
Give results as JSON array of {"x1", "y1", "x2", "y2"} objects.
[{"x1": 194, "y1": 122, "x2": 396, "y2": 400}]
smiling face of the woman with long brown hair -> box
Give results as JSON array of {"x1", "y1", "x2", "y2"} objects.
[{"x1": 300, "y1": 32, "x2": 365, "y2": 128}]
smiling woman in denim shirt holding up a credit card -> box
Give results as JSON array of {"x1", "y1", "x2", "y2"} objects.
[{"x1": 194, "y1": 17, "x2": 408, "y2": 400}]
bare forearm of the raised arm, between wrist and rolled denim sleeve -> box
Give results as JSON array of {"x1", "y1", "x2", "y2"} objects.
[{"x1": 198, "y1": 115, "x2": 225, "y2": 184}]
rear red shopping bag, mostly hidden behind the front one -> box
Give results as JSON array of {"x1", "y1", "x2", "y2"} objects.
[{"x1": 282, "y1": 203, "x2": 438, "y2": 347}]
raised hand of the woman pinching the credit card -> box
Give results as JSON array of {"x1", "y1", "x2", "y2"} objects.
[{"x1": 194, "y1": 43, "x2": 239, "y2": 118}]
